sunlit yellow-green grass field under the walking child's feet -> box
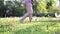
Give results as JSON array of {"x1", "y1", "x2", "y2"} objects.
[{"x1": 0, "y1": 17, "x2": 60, "y2": 34}]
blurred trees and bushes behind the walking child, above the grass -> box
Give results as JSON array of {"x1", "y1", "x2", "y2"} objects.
[{"x1": 0, "y1": 0, "x2": 60, "y2": 17}]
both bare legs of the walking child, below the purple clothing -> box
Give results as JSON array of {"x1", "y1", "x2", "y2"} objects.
[{"x1": 20, "y1": 3, "x2": 33, "y2": 23}]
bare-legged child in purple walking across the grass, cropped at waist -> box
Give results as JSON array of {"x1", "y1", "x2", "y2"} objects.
[{"x1": 20, "y1": 0, "x2": 33, "y2": 23}]
